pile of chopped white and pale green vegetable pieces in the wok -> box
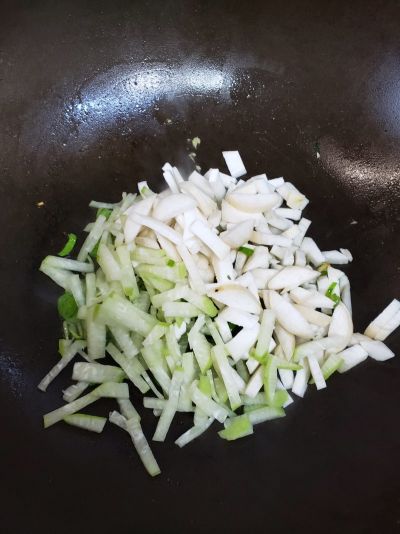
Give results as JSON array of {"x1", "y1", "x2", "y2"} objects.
[{"x1": 39, "y1": 151, "x2": 400, "y2": 476}]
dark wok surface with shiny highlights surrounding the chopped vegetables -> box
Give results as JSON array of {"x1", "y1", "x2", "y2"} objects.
[{"x1": 0, "y1": 0, "x2": 400, "y2": 534}]
